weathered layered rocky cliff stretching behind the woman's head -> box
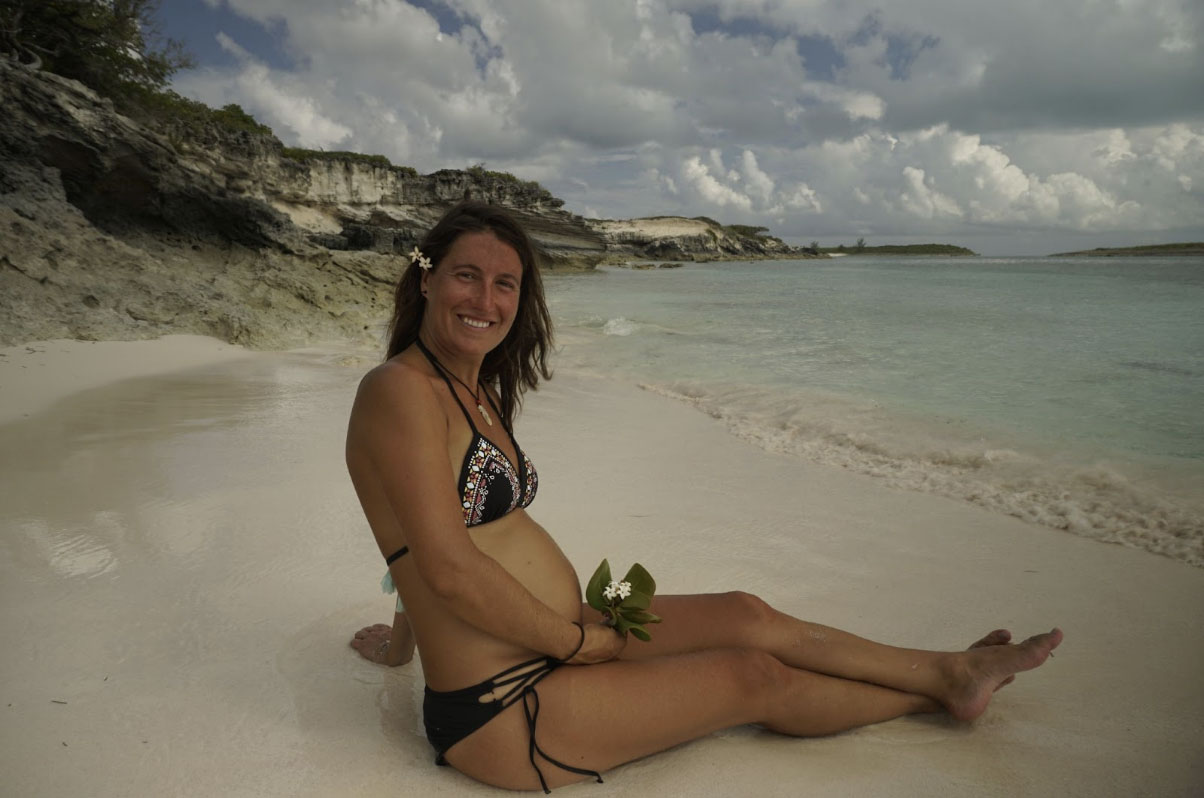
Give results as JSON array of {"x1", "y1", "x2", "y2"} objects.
[{"x1": 0, "y1": 59, "x2": 809, "y2": 348}]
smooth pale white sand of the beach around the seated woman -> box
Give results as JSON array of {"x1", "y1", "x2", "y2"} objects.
[{"x1": 0, "y1": 338, "x2": 1204, "y2": 797}]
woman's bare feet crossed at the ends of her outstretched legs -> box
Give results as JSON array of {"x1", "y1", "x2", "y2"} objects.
[{"x1": 944, "y1": 629, "x2": 1062, "y2": 721}]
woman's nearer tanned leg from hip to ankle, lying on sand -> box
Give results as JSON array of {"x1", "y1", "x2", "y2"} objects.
[{"x1": 447, "y1": 644, "x2": 939, "y2": 790}]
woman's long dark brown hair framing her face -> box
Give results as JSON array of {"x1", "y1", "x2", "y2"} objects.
[{"x1": 385, "y1": 201, "x2": 551, "y2": 430}]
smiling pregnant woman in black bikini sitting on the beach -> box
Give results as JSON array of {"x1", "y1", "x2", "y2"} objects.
[{"x1": 347, "y1": 202, "x2": 1062, "y2": 791}]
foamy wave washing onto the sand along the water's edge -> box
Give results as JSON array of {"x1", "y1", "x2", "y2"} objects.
[{"x1": 641, "y1": 383, "x2": 1204, "y2": 567}]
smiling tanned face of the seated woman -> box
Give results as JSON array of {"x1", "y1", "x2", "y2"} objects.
[{"x1": 421, "y1": 231, "x2": 523, "y2": 357}]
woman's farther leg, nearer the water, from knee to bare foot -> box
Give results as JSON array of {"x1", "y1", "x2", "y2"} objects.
[{"x1": 585, "y1": 592, "x2": 1062, "y2": 720}]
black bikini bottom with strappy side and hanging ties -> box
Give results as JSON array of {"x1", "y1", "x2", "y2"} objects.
[{"x1": 423, "y1": 657, "x2": 602, "y2": 792}]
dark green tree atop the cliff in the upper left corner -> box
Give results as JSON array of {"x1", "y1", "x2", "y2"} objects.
[{"x1": 0, "y1": 0, "x2": 191, "y2": 99}]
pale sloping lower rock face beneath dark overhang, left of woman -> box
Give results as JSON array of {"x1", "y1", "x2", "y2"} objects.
[{"x1": 0, "y1": 156, "x2": 399, "y2": 348}]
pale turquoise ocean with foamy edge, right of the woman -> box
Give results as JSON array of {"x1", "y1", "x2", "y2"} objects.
[{"x1": 547, "y1": 256, "x2": 1204, "y2": 567}]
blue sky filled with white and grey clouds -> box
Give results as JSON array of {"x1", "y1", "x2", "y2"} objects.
[{"x1": 159, "y1": 0, "x2": 1204, "y2": 255}]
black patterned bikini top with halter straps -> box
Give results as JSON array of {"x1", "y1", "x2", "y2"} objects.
[{"x1": 385, "y1": 341, "x2": 539, "y2": 564}]
